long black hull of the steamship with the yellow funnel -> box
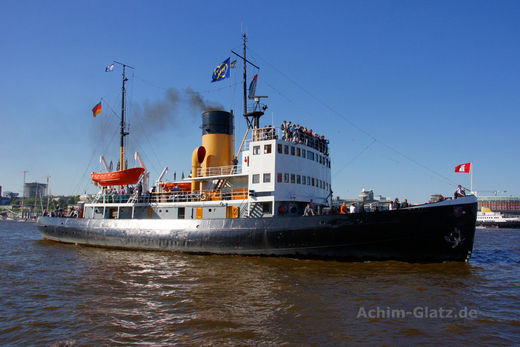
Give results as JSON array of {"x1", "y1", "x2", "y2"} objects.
[{"x1": 38, "y1": 197, "x2": 477, "y2": 262}]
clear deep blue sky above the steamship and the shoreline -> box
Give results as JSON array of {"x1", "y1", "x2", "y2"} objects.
[{"x1": 0, "y1": 0, "x2": 520, "y2": 202}]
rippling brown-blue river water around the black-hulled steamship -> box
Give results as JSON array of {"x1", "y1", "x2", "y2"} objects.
[{"x1": 0, "y1": 221, "x2": 520, "y2": 346}]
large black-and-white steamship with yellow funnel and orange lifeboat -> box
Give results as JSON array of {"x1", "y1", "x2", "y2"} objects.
[{"x1": 38, "y1": 35, "x2": 477, "y2": 262}]
